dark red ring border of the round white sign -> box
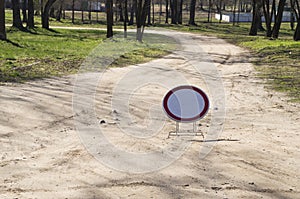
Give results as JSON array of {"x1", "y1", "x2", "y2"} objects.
[{"x1": 163, "y1": 85, "x2": 209, "y2": 122}]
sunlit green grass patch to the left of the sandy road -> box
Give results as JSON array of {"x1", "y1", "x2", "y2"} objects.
[{"x1": 0, "y1": 28, "x2": 176, "y2": 82}]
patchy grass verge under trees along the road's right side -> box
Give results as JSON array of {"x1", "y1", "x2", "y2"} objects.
[{"x1": 160, "y1": 23, "x2": 300, "y2": 102}]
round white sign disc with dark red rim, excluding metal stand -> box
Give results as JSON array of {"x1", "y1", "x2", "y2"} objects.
[{"x1": 163, "y1": 85, "x2": 209, "y2": 122}]
